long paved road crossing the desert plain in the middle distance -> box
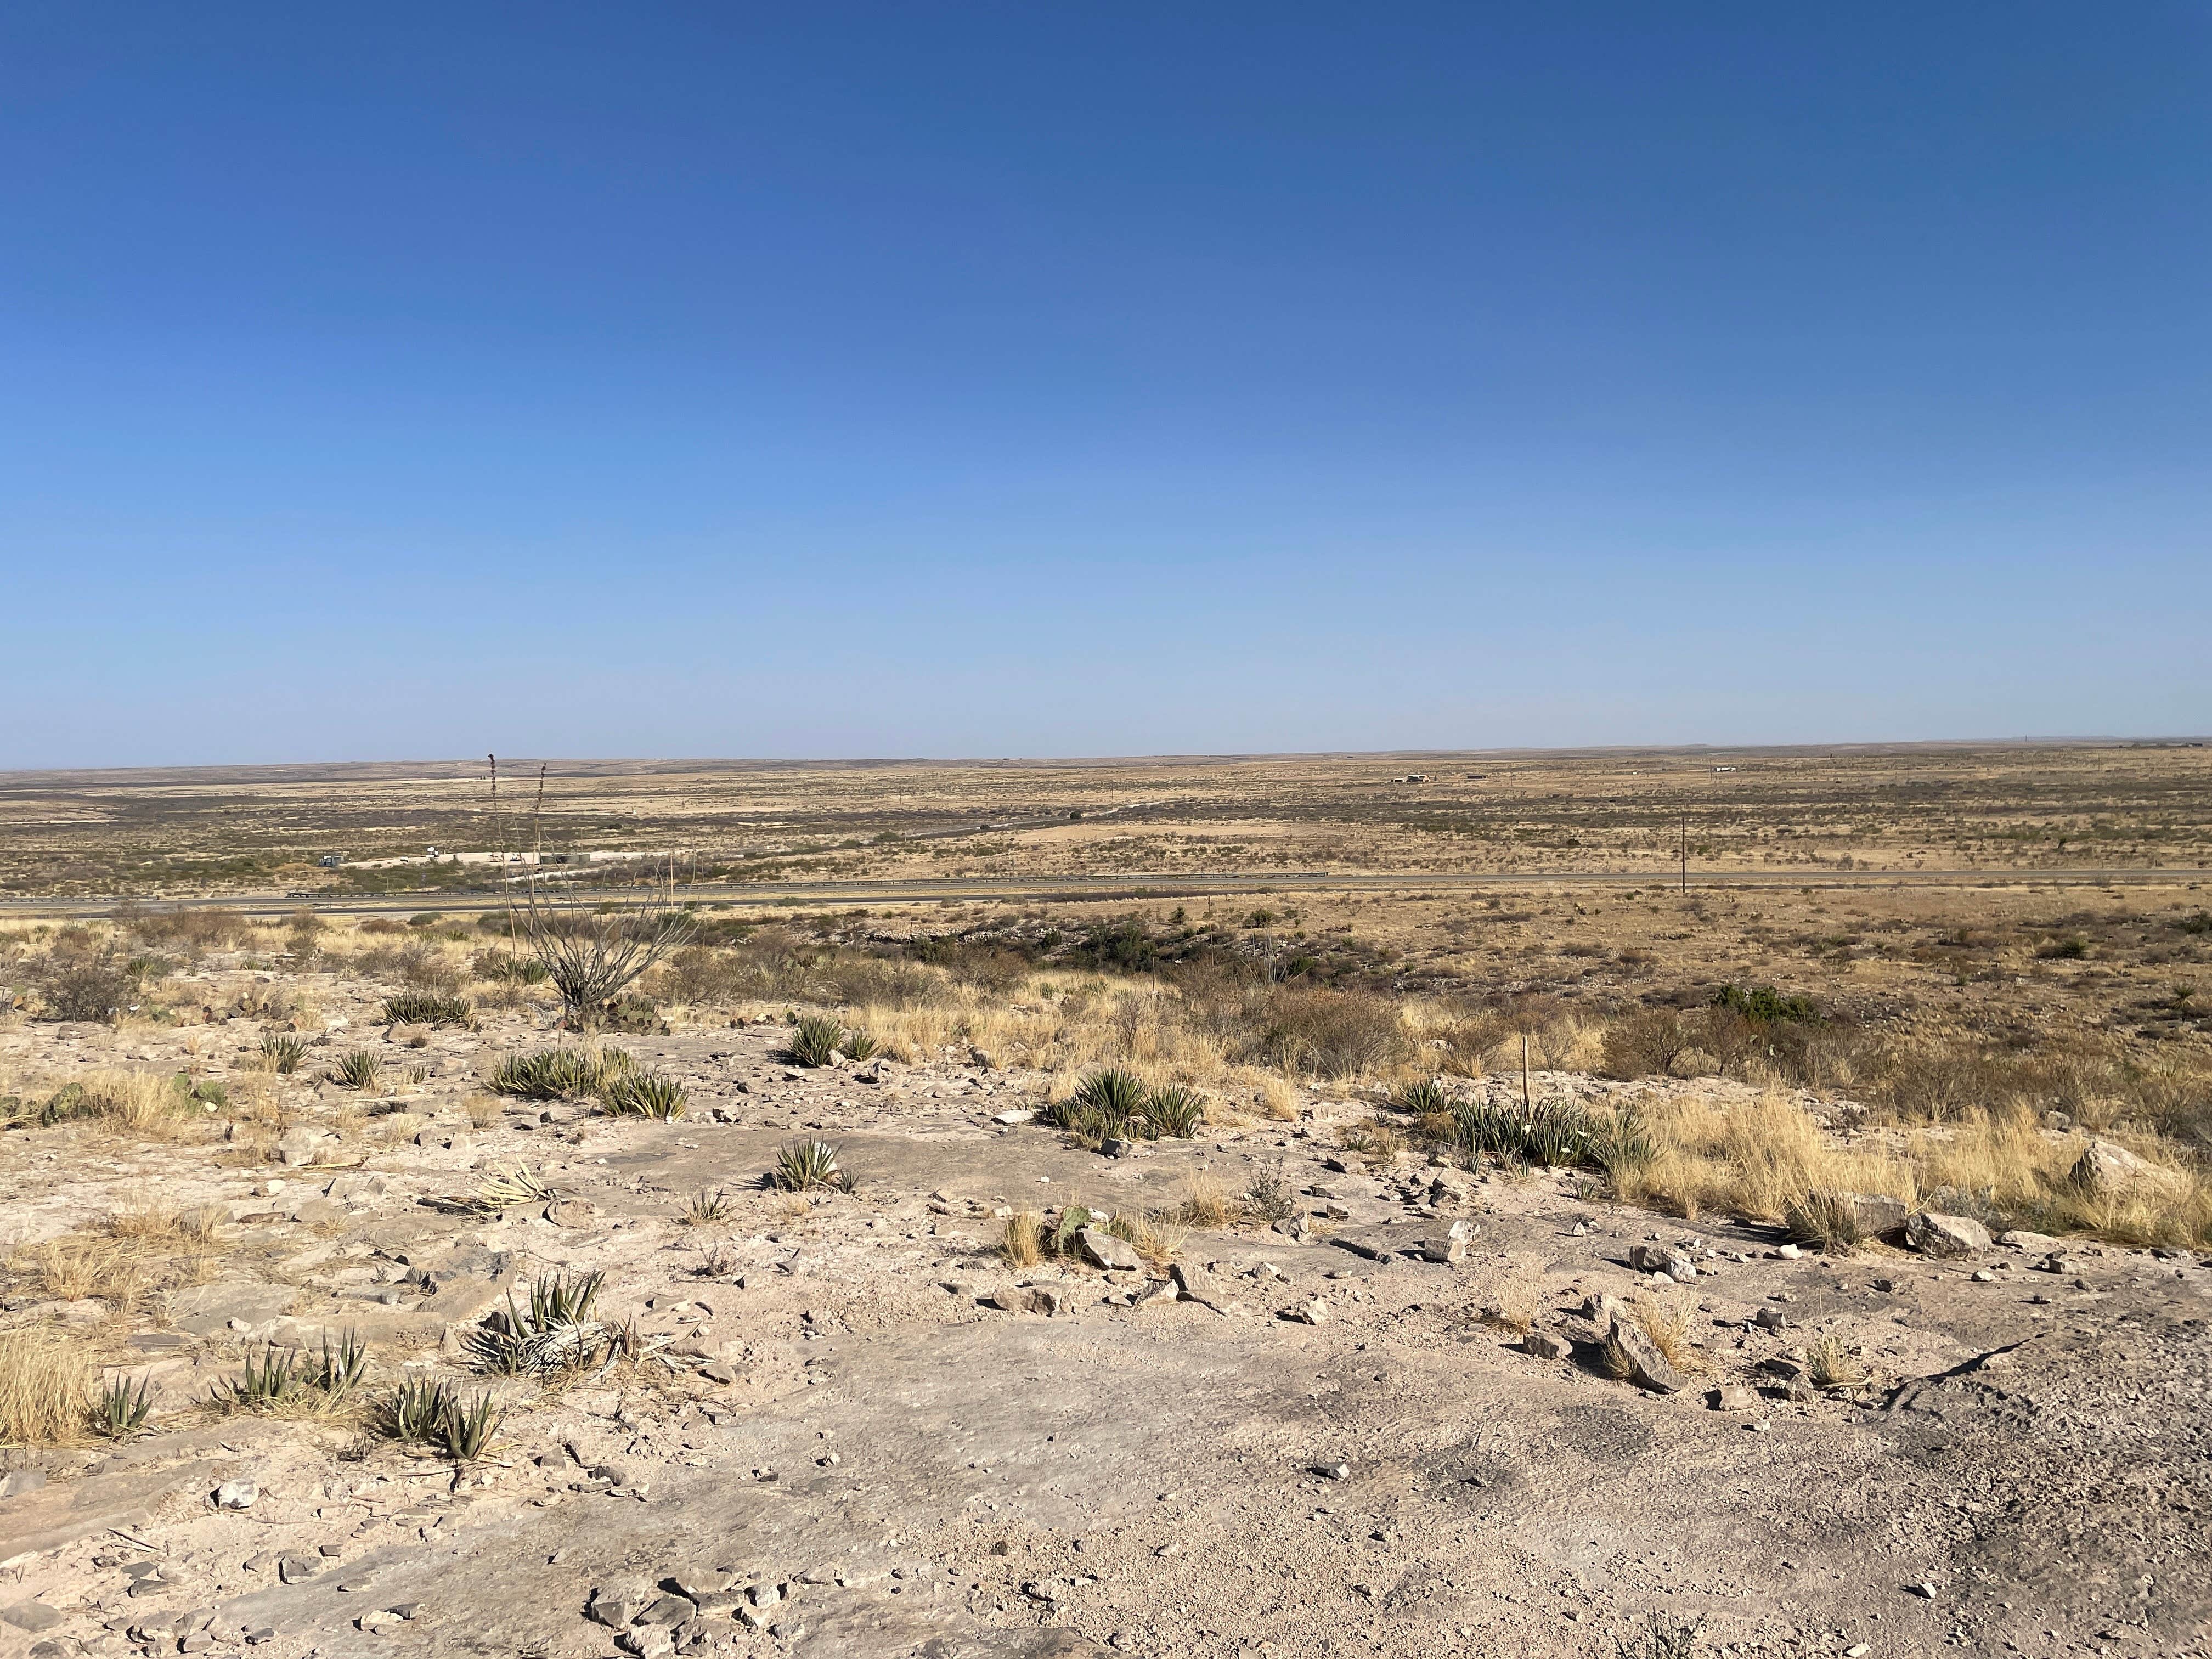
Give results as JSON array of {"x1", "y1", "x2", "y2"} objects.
[{"x1": 0, "y1": 867, "x2": 2212, "y2": 916}]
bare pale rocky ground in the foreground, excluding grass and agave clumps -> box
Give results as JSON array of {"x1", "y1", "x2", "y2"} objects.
[{"x1": 0, "y1": 986, "x2": 2212, "y2": 1659}]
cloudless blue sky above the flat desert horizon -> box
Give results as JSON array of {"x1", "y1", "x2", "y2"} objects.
[{"x1": 0, "y1": 0, "x2": 2212, "y2": 765}]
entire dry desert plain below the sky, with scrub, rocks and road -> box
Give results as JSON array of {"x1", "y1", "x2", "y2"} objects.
[{"x1": 0, "y1": 746, "x2": 2212, "y2": 1659}]
